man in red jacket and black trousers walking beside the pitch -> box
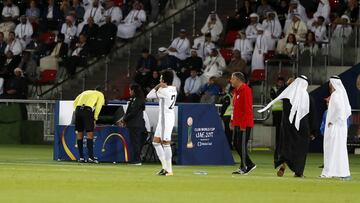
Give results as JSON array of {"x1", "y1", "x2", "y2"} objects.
[{"x1": 230, "y1": 72, "x2": 256, "y2": 174}]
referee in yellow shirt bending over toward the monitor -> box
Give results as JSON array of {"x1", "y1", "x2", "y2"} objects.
[{"x1": 74, "y1": 90, "x2": 105, "y2": 163}]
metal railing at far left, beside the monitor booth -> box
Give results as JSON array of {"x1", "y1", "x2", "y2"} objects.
[{"x1": 0, "y1": 99, "x2": 55, "y2": 139}]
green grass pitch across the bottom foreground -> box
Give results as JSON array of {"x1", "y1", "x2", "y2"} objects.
[{"x1": 0, "y1": 145, "x2": 360, "y2": 203}]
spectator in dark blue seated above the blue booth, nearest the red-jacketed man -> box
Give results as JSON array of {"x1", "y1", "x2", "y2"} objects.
[{"x1": 200, "y1": 77, "x2": 220, "y2": 104}]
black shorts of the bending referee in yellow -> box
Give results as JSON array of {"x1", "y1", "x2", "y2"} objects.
[{"x1": 75, "y1": 106, "x2": 94, "y2": 132}]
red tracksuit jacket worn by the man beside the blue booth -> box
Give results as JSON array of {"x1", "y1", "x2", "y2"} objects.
[{"x1": 231, "y1": 84, "x2": 254, "y2": 129}]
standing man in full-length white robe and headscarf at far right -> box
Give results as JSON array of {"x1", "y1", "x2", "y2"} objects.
[{"x1": 320, "y1": 76, "x2": 351, "y2": 178}]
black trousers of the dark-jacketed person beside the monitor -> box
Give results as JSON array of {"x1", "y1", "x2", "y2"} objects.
[{"x1": 128, "y1": 127, "x2": 146, "y2": 163}]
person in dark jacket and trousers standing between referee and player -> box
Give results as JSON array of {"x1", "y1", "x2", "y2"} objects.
[{"x1": 118, "y1": 84, "x2": 146, "y2": 165}]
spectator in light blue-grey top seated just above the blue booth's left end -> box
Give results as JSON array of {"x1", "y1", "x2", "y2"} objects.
[{"x1": 184, "y1": 68, "x2": 201, "y2": 103}]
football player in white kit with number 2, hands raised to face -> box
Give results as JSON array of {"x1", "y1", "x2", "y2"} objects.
[{"x1": 147, "y1": 70, "x2": 177, "y2": 176}]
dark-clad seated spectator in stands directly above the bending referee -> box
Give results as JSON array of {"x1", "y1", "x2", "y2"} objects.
[{"x1": 65, "y1": 34, "x2": 90, "y2": 77}]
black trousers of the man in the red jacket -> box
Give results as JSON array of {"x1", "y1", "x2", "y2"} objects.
[{"x1": 234, "y1": 126, "x2": 255, "y2": 171}]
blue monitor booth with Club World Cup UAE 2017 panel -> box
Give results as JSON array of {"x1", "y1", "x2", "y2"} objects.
[{"x1": 54, "y1": 101, "x2": 234, "y2": 165}]
